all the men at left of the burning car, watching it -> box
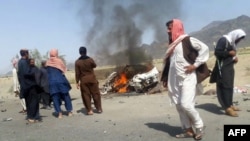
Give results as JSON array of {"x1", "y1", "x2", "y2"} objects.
[{"x1": 12, "y1": 47, "x2": 103, "y2": 123}]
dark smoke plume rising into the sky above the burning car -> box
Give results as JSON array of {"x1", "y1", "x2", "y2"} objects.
[{"x1": 78, "y1": 0, "x2": 181, "y2": 65}]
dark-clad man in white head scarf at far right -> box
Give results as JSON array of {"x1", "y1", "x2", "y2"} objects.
[{"x1": 210, "y1": 29, "x2": 246, "y2": 117}]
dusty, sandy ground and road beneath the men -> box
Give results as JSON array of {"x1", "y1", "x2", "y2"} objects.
[{"x1": 0, "y1": 55, "x2": 250, "y2": 141}]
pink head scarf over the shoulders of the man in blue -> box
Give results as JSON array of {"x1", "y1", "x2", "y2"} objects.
[{"x1": 46, "y1": 49, "x2": 66, "y2": 73}]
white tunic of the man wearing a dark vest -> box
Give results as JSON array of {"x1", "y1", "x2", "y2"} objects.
[{"x1": 168, "y1": 37, "x2": 209, "y2": 104}]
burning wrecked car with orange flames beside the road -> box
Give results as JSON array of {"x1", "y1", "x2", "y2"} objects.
[{"x1": 100, "y1": 65, "x2": 159, "y2": 95}]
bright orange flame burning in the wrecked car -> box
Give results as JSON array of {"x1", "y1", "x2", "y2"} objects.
[{"x1": 114, "y1": 73, "x2": 128, "y2": 93}]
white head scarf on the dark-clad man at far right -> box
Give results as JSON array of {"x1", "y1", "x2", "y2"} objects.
[{"x1": 223, "y1": 29, "x2": 246, "y2": 48}]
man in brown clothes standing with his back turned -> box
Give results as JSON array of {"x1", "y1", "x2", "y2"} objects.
[{"x1": 75, "y1": 47, "x2": 102, "y2": 115}]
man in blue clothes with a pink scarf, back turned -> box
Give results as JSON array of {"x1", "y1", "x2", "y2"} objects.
[{"x1": 46, "y1": 48, "x2": 73, "y2": 119}]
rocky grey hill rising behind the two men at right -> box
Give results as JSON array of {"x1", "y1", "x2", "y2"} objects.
[{"x1": 142, "y1": 15, "x2": 250, "y2": 59}]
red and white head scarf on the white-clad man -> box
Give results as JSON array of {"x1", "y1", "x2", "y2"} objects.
[{"x1": 165, "y1": 19, "x2": 188, "y2": 58}]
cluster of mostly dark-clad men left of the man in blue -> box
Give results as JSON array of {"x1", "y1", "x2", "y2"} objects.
[{"x1": 12, "y1": 49, "x2": 51, "y2": 120}]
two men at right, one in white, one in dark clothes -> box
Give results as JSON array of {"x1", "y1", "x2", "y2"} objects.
[{"x1": 161, "y1": 19, "x2": 246, "y2": 140}]
